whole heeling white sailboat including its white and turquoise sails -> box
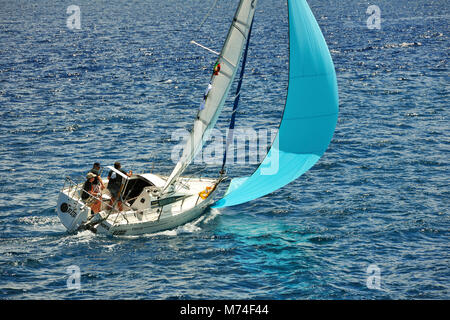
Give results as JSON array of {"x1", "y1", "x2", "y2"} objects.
[{"x1": 56, "y1": 0, "x2": 338, "y2": 235}]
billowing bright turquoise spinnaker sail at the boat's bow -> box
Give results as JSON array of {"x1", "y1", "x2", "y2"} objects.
[{"x1": 212, "y1": 0, "x2": 339, "y2": 208}]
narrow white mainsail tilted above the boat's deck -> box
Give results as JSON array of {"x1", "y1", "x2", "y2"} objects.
[{"x1": 162, "y1": 0, "x2": 257, "y2": 192}]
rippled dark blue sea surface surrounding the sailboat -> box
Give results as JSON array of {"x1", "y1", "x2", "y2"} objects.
[{"x1": 0, "y1": 0, "x2": 450, "y2": 300}]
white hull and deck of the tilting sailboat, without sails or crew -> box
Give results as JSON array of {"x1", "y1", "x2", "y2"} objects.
[{"x1": 57, "y1": 174, "x2": 220, "y2": 235}]
